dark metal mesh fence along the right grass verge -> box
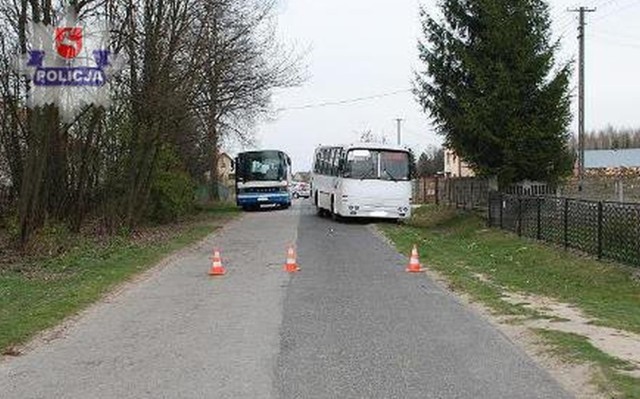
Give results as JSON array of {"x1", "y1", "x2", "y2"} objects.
[{"x1": 488, "y1": 192, "x2": 640, "y2": 266}]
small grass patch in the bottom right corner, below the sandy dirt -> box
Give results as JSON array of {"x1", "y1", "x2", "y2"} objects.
[{"x1": 535, "y1": 329, "x2": 640, "y2": 398}]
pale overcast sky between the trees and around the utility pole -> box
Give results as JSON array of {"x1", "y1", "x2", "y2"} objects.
[{"x1": 244, "y1": 0, "x2": 640, "y2": 171}]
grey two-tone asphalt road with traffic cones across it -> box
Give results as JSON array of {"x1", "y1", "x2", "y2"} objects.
[{"x1": 0, "y1": 200, "x2": 570, "y2": 398}]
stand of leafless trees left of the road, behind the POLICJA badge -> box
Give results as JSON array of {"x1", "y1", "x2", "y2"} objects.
[{"x1": 0, "y1": 0, "x2": 302, "y2": 244}]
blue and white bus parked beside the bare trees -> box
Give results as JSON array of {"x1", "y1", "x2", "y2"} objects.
[{"x1": 235, "y1": 150, "x2": 292, "y2": 210}]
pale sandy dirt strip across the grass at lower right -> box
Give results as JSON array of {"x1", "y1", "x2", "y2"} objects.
[{"x1": 503, "y1": 293, "x2": 640, "y2": 378}]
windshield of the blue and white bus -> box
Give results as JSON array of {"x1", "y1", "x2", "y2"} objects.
[{"x1": 237, "y1": 151, "x2": 287, "y2": 182}]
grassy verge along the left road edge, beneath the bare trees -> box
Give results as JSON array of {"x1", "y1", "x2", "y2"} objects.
[{"x1": 0, "y1": 206, "x2": 237, "y2": 354}]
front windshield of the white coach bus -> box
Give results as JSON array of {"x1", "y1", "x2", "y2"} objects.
[{"x1": 343, "y1": 149, "x2": 410, "y2": 181}]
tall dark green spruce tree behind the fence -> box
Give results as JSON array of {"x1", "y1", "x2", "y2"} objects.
[{"x1": 414, "y1": 0, "x2": 572, "y2": 185}]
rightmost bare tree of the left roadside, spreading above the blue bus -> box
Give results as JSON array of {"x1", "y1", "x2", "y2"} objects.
[{"x1": 196, "y1": 0, "x2": 302, "y2": 198}]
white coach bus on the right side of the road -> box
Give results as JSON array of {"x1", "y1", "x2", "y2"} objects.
[{"x1": 311, "y1": 143, "x2": 412, "y2": 219}]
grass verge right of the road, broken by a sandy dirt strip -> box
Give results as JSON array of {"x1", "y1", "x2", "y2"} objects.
[{"x1": 381, "y1": 206, "x2": 640, "y2": 397}]
